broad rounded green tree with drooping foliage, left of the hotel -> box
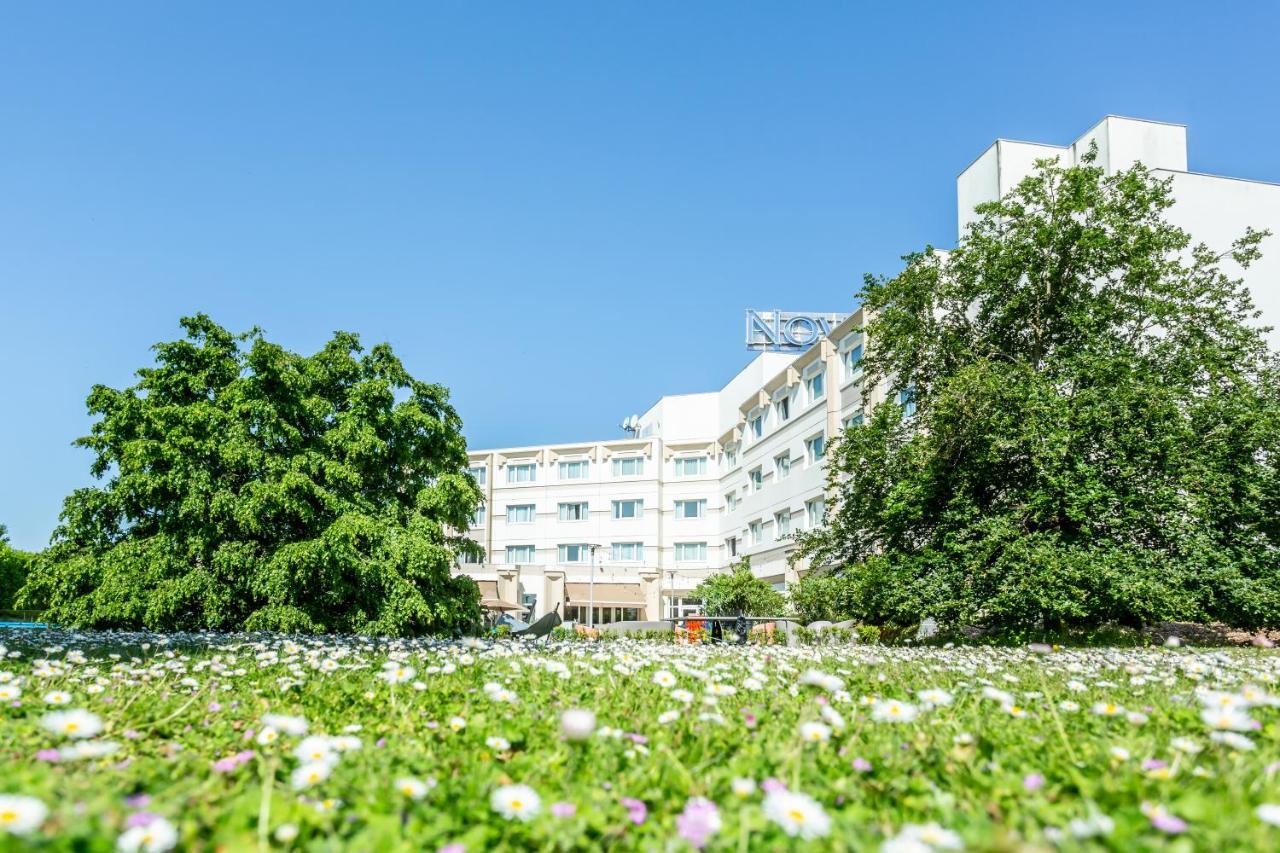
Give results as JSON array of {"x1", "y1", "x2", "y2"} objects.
[{"x1": 19, "y1": 315, "x2": 480, "y2": 635}]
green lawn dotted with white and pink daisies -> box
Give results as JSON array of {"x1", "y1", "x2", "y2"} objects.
[{"x1": 0, "y1": 630, "x2": 1280, "y2": 852}]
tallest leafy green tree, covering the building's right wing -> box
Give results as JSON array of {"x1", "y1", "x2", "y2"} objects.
[{"x1": 800, "y1": 156, "x2": 1280, "y2": 626}]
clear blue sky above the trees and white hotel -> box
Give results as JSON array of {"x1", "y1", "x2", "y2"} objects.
[{"x1": 0, "y1": 1, "x2": 1280, "y2": 548}]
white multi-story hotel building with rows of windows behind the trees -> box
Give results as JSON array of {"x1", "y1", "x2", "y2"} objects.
[{"x1": 460, "y1": 117, "x2": 1280, "y2": 624}]
